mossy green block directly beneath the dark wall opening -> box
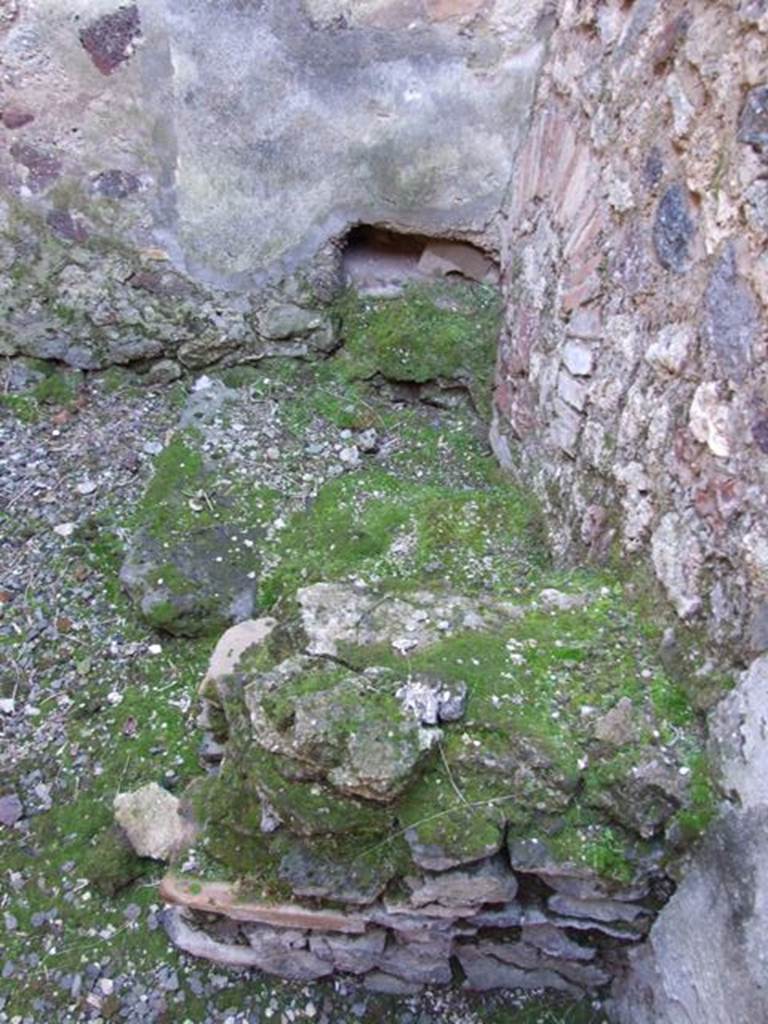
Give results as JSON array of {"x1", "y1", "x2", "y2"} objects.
[{"x1": 331, "y1": 283, "x2": 501, "y2": 415}]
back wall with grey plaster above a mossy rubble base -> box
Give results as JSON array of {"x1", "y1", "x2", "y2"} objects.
[{"x1": 0, "y1": 0, "x2": 548, "y2": 378}]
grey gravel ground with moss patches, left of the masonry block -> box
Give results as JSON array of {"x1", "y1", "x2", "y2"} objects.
[{"x1": 0, "y1": 364, "x2": 603, "y2": 1024}]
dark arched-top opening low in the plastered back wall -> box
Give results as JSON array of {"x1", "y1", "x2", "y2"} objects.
[{"x1": 342, "y1": 224, "x2": 499, "y2": 296}]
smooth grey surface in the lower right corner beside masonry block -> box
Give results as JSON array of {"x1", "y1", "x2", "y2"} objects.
[{"x1": 613, "y1": 657, "x2": 768, "y2": 1024}]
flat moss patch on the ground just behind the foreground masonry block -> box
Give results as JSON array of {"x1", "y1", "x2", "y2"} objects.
[{"x1": 263, "y1": 469, "x2": 545, "y2": 606}]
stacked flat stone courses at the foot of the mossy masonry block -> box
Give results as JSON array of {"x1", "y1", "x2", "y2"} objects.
[{"x1": 161, "y1": 851, "x2": 654, "y2": 997}]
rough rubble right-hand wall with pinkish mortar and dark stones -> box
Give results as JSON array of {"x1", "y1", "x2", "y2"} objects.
[{"x1": 493, "y1": 0, "x2": 768, "y2": 659}]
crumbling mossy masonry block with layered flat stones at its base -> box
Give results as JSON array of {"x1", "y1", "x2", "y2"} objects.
[{"x1": 138, "y1": 584, "x2": 708, "y2": 996}]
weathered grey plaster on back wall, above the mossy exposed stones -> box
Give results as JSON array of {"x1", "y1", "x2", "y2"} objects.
[{"x1": 0, "y1": 0, "x2": 544, "y2": 289}]
